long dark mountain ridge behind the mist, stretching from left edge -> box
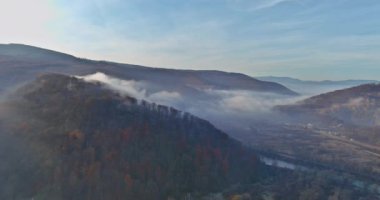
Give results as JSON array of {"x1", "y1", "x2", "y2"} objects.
[{"x1": 0, "y1": 44, "x2": 297, "y2": 95}]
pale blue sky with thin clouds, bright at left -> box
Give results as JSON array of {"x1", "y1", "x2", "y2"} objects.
[{"x1": 0, "y1": 0, "x2": 380, "y2": 80}]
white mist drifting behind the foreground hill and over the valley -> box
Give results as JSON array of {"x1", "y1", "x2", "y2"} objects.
[{"x1": 77, "y1": 72, "x2": 308, "y2": 141}]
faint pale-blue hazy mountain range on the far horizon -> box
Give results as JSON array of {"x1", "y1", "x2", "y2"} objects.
[{"x1": 256, "y1": 76, "x2": 379, "y2": 95}]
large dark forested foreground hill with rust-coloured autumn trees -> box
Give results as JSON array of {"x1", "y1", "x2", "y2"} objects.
[{"x1": 0, "y1": 74, "x2": 262, "y2": 199}]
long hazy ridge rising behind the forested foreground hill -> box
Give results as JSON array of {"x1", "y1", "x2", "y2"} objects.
[{"x1": 0, "y1": 44, "x2": 296, "y2": 96}]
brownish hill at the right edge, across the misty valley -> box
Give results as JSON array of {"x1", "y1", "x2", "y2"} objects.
[{"x1": 278, "y1": 84, "x2": 380, "y2": 126}]
